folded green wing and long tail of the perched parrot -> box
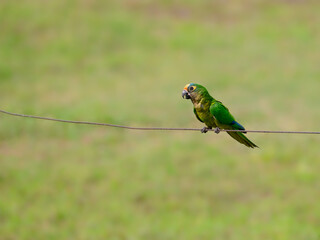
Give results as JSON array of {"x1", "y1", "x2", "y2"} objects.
[{"x1": 210, "y1": 101, "x2": 258, "y2": 148}]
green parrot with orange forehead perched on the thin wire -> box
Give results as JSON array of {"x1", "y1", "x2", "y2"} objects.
[{"x1": 182, "y1": 83, "x2": 258, "y2": 148}]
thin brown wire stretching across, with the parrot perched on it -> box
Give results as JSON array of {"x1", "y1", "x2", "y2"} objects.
[{"x1": 0, "y1": 109, "x2": 320, "y2": 134}]
